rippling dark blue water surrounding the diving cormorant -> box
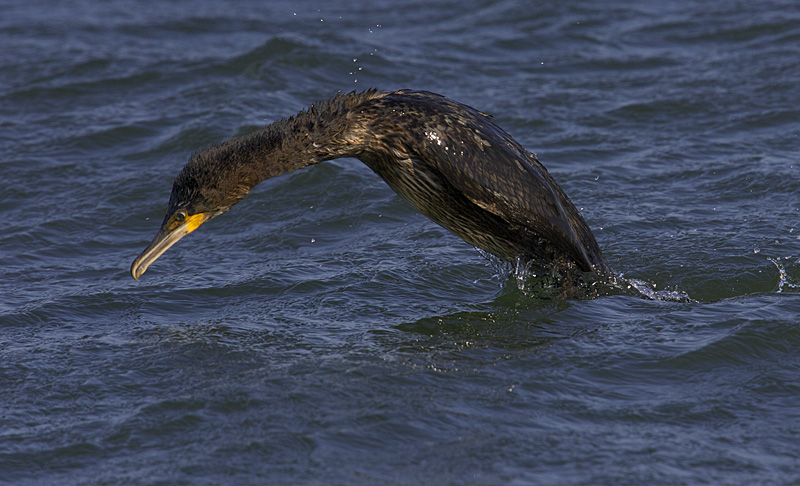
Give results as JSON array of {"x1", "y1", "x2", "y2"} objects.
[{"x1": 0, "y1": 0, "x2": 800, "y2": 485}]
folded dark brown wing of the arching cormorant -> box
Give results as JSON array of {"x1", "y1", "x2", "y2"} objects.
[{"x1": 356, "y1": 91, "x2": 607, "y2": 271}]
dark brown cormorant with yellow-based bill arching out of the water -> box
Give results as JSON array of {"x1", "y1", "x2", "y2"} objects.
[{"x1": 131, "y1": 89, "x2": 613, "y2": 285}]
